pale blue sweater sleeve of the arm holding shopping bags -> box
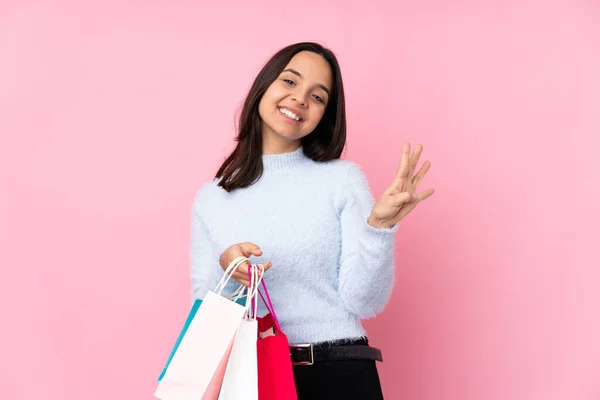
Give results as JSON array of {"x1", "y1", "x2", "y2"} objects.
[{"x1": 190, "y1": 191, "x2": 219, "y2": 301}]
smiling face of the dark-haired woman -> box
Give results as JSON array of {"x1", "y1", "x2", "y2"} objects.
[{"x1": 258, "y1": 51, "x2": 333, "y2": 147}]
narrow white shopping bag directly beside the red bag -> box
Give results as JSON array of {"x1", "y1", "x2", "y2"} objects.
[{"x1": 219, "y1": 265, "x2": 264, "y2": 400}]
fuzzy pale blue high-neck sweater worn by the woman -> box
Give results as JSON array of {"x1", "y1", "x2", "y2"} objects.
[{"x1": 191, "y1": 147, "x2": 397, "y2": 344}]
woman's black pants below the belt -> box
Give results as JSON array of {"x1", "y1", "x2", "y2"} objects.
[{"x1": 294, "y1": 340, "x2": 383, "y2": 400}]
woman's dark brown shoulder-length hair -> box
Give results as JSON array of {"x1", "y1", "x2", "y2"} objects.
[{"x1": 215, "y1": 42, "x2": 346, "y2": 192}]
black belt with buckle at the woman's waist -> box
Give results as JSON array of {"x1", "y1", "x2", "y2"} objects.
[{"x1": 290, "y1": 344, "x2": 383, "y2": 365}]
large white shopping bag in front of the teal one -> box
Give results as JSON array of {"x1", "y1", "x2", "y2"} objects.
[{"x1": 154, "y1": 257, "x2": 249, "y2": 400}]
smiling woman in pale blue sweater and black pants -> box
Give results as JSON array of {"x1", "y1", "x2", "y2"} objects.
[{"x1": 191, "y1": 43, "x2": 433, "y2": 400}]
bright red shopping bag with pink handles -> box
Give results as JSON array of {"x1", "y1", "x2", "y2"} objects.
[{"x1": 256, "y1": 280, "x2": 298, "y2": 400}]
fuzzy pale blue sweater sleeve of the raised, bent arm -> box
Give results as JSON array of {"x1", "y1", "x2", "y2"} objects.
[{"x1": 338, "y1": 163, "x2": 398, "y2": 318}]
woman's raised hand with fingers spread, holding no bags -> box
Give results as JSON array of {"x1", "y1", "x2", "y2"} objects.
[{"x1": 369, "y1": 143, "x2": 433, "y2": 228}]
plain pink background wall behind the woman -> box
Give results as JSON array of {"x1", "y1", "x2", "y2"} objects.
[{"x1": 0, "y1": 0, "x2": 600, "y2": 400}]
